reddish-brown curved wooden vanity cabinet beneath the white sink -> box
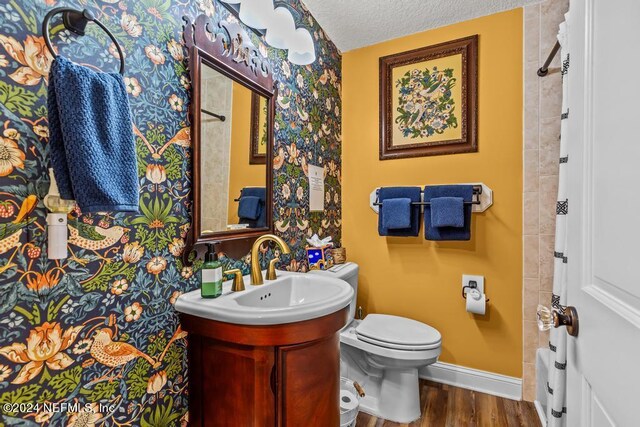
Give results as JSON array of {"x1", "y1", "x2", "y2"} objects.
[{"x1": 180, "y1": 308, "x2": 348, "y2": 427}]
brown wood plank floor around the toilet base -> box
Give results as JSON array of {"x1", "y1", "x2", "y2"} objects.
[{"x1": 356, "y1": 380, "x2": 540, "y2": 427}]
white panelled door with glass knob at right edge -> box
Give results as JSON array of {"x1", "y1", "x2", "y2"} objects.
[{"x1": 567, "y1": 0, "x2": 640, "y2": 427}]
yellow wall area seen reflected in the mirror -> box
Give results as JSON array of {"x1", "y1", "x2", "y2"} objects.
[{"x1": 228, "y1": 82, "x2": 266, "y2": 224}]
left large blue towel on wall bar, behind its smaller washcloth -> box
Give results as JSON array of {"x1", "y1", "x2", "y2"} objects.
[{"x1": 378, "y1": 187, "x2": 420, "y2": 237}]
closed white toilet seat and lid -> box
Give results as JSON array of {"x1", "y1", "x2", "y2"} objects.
[{"x1": 355, "y1": 314, "x2": 442, "y2": 351}]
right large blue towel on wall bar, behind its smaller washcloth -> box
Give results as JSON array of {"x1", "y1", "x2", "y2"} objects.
[{"x1": 424, "y1": 185, "x2": 473, "y2": 240}]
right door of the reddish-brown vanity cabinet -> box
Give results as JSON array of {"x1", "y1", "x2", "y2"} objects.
[{"x1": 277, "y1": 333, "x2": 340, "y2": 427}]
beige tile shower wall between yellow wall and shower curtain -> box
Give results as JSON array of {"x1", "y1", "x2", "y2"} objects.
[{"x1": 522, "y1": 0, "x2": 569, "y2": 401}]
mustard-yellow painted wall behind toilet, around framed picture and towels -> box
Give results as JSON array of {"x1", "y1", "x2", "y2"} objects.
[{"x1": 342, "y1": 9, "x2": 523, "y2": 377}]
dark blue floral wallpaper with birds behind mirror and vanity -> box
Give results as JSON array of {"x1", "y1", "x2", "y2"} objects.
[{"x1": 0, "y1": 0, "x2": 341, "y2": 427}]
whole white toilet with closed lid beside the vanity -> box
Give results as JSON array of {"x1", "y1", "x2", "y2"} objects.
[{"x1": 311, "y1": 262, "x2": 442, "y2": 423}]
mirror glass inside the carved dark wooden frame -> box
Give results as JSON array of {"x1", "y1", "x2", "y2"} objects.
[{"x1": 200, "y1": 61, "x2": 268, "y2": 236}]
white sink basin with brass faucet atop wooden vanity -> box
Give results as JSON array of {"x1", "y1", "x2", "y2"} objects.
[{"x1": 175, "y1": 271, "x2": 353, "y2": 325}]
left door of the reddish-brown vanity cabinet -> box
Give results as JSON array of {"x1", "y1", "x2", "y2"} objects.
[{"x1": 190, "y1": 337, "x2": 275, "y2": 427}]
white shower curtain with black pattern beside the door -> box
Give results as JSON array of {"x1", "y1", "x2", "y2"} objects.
[{"x1": 547, "y1": 13, "x2": 569, "y2": 427}]
